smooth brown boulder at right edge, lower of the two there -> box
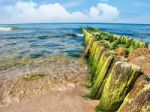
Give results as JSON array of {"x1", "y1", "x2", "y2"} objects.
[{"x1": 130, "y1": 55, "x2": 150, "y2": 78}]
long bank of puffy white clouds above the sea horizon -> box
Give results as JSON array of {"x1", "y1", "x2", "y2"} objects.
[{"x1": 0, "y1": 2, "x2": 119, "y2": 23}]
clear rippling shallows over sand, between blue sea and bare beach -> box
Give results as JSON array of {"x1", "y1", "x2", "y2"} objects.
[{"x1": 0, "y1": 56, "x2": 89, "y2": 107}]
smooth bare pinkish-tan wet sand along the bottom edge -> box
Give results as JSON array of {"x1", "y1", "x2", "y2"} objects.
[{"x1": 1, "y1": 87, "x2": 98, "y2": 112}]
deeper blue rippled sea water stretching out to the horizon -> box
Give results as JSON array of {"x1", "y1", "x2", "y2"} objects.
[{"x1": 0, "y1": 23, "x2": 150, "y2": 60}]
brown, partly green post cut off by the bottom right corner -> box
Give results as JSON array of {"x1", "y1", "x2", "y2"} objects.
[{"x1": 118, "y1": 75, "x2": 150, "y2": 112}]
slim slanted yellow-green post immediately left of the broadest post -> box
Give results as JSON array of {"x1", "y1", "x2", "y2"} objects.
[{"x1": 90, "y1": 56, "x2": 114, "y2": 99}]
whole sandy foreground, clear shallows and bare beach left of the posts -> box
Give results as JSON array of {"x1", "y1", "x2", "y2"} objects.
[{"x1": 0, "y1": 56, "x2": 97, "y2": 112}]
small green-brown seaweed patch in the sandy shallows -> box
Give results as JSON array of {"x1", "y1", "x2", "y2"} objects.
[{"x1": 23, "y1": 73, "x2": 45, "y2": 81}]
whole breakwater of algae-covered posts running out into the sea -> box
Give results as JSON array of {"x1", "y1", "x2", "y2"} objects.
[{"x1": 83, "y1": 28, "x2": 150, "y2": 112}]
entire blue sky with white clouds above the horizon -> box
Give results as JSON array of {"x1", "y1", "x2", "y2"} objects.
[{"x1": 0, "y1": 0, "x2": 150, "y2": 24}]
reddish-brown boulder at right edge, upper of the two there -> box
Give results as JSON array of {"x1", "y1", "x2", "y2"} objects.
[{"x1": 128, "y1": 48, "x2": 150, "y2": 61}]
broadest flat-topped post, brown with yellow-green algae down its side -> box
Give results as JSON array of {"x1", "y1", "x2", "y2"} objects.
[{"x1": 97, "y1": 61, "x2": 141, "y2": 112}]
